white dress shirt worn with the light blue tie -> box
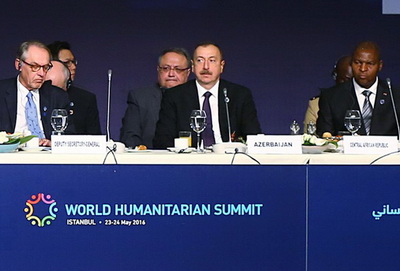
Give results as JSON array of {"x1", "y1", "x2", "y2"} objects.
[{"x1": 14, "y1": 76, "x2": 44, "y2": 135}]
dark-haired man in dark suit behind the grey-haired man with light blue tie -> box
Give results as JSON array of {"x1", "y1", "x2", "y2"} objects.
[{"x1": 48, "y1": 41, "x2": 101, "y2": 135}]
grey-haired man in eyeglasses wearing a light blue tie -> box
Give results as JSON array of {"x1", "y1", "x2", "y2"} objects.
[{"x1": 0, "y1": 41, "x2": 73, "y2": 146}]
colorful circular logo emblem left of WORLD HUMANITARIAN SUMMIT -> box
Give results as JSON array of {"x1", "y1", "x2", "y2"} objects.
[{"x1": 24, "y1": 193, "x2": 58, "y2": 227}]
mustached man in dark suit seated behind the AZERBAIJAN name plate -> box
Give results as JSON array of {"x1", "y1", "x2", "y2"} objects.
[{"x1": 153, "y1": 43, "x2": 261, "y2": 148}]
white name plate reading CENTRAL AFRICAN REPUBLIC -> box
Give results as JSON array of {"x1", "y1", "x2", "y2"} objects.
[{"x1": 343, "y1": 136, "x2": 398, "y2": 154}]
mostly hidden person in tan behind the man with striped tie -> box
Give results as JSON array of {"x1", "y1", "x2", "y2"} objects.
[{"x1": 304, "y1": 56, "x2": 353, "y2": 133}]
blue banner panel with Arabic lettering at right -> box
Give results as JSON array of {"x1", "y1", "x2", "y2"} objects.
[{"x1": 308, "y1": 166, "x2": 400, "y2": 271}]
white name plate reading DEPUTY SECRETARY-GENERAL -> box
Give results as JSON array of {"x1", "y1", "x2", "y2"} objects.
[{"x1": 51, "y1": 135, "x2": 107, "y2": 153}]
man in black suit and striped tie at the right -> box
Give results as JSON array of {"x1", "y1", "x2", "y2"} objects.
[{"x1": 317, "y1": 41, "x2": 400, "y2": 136}]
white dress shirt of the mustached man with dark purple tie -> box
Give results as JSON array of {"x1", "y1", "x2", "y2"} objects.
[{"x1": 196, "y1": 80, "x2": 222, "y2": 143}]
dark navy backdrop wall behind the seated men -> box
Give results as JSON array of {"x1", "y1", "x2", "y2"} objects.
[{"x1": 0, "y1": 0, "x2": 400, "y2": 140}]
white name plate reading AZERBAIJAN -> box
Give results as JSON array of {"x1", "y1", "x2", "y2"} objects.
[{"x1": 247, "y1": 135, "x2": 303, "y2": 154}]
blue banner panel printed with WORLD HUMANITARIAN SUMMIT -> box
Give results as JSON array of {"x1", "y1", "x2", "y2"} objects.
[{"x1": 0, "y1": 165, "x2": 306, "y2": 271}]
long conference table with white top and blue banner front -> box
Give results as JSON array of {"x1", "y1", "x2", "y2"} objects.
[{"x1": 0, "y1": 151, "x2": 400, "y2": 271}]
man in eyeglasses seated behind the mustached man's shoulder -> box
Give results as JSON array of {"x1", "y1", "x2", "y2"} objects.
[{"x1": 121, "y1": 48, "x2": 190, "y2": 148}]
